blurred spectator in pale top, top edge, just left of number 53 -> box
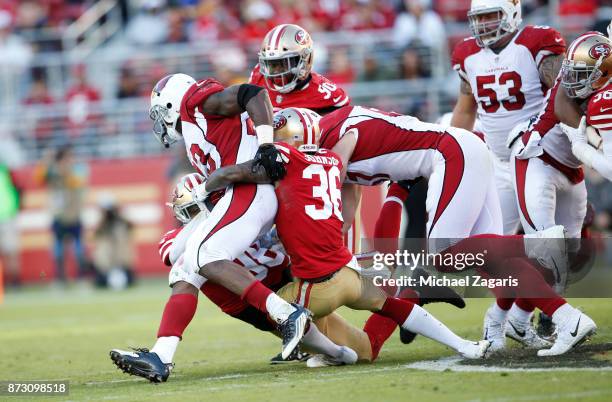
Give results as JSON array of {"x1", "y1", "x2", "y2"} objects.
[{"x1": 393, "y1": 0, "x2": 446, "y2": 52}]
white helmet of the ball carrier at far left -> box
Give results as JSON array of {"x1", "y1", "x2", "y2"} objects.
[{"x1": 149, "y1": 74, "x2": 195, "y2": 148}]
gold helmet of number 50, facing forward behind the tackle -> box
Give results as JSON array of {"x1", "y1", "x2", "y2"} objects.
[{"x1": 258, "y1": 24, "x2": 313, "y2": 93}]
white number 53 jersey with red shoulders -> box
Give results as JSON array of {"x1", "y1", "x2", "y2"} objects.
[{"x1": 451, "y1": 25, "x2": 565, "y2": 160}]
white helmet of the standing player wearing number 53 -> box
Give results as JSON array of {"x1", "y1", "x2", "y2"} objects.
[{"x1": 468, "y1": 0, "x2": 522, "y2": 47}]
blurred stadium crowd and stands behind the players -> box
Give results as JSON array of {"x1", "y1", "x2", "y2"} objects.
[{"x1": 0, "y1": 0, "x2": 612, "y2": 286}]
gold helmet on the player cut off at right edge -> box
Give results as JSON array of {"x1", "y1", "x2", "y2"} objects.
[{"x1": 561, "y1": 32, "x2": 612, "y2": 99}]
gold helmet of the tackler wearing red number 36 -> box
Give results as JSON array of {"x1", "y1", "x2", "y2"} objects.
[{"x1": 274, "y1": 107, "x2": 321, "y2": 152}]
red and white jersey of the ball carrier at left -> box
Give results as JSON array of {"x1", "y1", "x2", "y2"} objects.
[{"x1": 181, "y1": 78, "x2": 258, "y2": 177}]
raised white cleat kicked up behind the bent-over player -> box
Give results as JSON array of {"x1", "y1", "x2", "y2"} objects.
[{"x1": 524, "y1": 225, "x2": 569, "y2": 292}]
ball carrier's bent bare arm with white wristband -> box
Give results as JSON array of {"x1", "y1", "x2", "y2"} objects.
[{"x1": 202, "y1": 84, "x2": 274, "y2": 144}]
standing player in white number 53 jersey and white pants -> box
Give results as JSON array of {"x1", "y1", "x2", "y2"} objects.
[{"x1": 451, "y1": 0, "x2": 565, "y2": 345}]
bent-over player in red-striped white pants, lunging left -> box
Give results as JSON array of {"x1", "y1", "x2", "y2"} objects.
[{"x1": 286, "y1": 106, "x2": 595, "y2": 356}]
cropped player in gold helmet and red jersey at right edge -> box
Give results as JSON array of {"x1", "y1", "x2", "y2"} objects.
[{"x1": 557, "y1": 32, "x2": 612, "y2": 180}]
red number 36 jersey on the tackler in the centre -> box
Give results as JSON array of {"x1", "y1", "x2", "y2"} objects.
[{"x1": 275, "y1": 142, "x2": 353, "y2": 279}]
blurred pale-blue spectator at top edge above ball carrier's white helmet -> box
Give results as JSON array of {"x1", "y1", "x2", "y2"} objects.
[{"x1": 126, "y1": 0, "x2": 170, "y2": 45}]
